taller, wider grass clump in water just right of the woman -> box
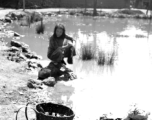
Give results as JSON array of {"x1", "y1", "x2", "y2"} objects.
[{"x1": 80, "y1": 44, "x2": 95, "y2": 60}]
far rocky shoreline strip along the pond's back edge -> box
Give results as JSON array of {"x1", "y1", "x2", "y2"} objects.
[{"x1": 1, "y1": 9, "x2": 152, "y2": 26}]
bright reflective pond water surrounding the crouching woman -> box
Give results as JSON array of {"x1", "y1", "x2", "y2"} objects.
[{"x1": 6, "y1": 16, "x2": 152, "y2": 119}]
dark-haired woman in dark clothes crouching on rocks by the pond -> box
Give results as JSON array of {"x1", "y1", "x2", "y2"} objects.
[{"x1": 47, "y1": 24, "x2": 76, "y2": 64}]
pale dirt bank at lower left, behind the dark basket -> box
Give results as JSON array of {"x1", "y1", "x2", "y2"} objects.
[{"x1": 0, "y1": 42, "x2": 74, "y2": 120}]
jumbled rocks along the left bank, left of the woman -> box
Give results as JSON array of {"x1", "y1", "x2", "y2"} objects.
[{"x1": 0, "y1": 28, "x2": 42, "y2": 69}]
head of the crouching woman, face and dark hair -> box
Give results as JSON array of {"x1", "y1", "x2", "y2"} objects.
[{"x1": 53, "y1": 24, "x2": 65, "y2": 38}]
